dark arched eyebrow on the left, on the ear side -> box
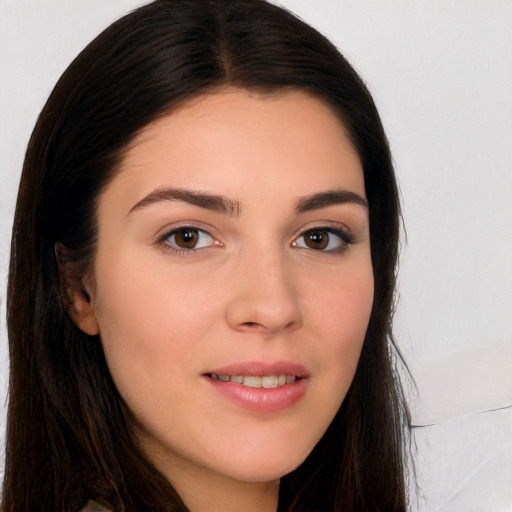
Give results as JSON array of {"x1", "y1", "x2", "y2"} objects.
[{"x1": 128, "y1": 187, "x2": 241, "y2": 217}]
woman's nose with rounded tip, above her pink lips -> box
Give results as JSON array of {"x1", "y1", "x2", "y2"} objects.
[{"x1": 226, "y1": 246, "x2": 302, "y2": 335}]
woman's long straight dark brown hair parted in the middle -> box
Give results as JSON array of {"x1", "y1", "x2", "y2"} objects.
[{"x1": 2, "y1": 0, "x2": 409, "y2": 512}]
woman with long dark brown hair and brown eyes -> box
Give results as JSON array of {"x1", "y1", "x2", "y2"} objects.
[{"x1": 3, "y1": 0, "x2": 408, "y2": 512}]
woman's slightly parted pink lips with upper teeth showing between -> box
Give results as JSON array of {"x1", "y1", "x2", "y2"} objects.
[{"x1": 203, "y1": 361, "x2": 310, "y2": 413}]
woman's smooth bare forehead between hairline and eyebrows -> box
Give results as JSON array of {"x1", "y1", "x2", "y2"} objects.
[{"x1": 101, "y1": 89, "x2": 364, "y2": 211}]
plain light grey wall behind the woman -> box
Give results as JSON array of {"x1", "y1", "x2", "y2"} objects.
[{"x1": 0, "y1": 0, "x2": 512, "y2": 512}]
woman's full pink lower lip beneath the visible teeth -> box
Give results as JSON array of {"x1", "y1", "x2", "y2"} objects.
[{"x1": 204, "y1": 376, "x2": 308, "y2": 413}]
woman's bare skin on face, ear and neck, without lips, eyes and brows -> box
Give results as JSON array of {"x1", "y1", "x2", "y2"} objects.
[{"x1": 74, "y1": 89, "x2": 373, "y2": 512}]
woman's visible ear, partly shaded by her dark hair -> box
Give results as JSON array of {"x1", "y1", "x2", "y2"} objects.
[{"x1": 55, "y1": 242, "x2": 99, "y2": 336}]
